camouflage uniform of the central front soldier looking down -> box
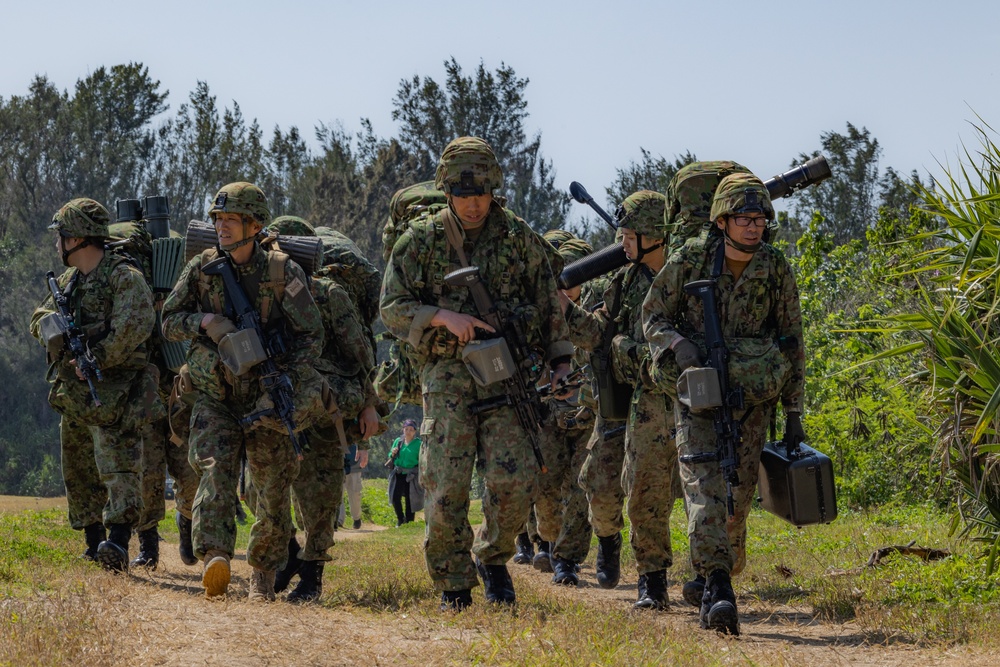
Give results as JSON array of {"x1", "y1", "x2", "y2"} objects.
[{"x1": 381, "y1": 185, "x2": 573, "y2": 591}]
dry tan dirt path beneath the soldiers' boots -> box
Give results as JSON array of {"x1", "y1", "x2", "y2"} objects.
[{"x1": 0, "y1": 498, "x2": 1000, "y2": 667}]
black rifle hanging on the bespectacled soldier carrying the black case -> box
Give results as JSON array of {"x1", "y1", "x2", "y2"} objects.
[{"x1": 680, "y1": 277, "x2": 744, "y2": 516}]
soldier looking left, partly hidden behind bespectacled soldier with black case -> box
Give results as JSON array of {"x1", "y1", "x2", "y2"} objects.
[{"x1": 567, "y1": 190, "x2": 677, "y2": 609}]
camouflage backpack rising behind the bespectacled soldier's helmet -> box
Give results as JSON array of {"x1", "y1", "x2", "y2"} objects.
[{"x1": 665, "y1": 160, "x2": 750, "y2": 257}]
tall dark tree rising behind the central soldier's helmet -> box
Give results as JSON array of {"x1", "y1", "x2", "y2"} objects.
[{"x1": 392, "y1": 58, "x2": 569, "y2": 231}]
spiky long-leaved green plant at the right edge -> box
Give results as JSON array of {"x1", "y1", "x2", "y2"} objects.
[{"x1": 868, "y1": 124, "x2": 1000, "y2": 571}]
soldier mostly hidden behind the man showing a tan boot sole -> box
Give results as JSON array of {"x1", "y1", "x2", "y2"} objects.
[{"x1": 267, "y1": 216, "x2": 379, "y2": 602}]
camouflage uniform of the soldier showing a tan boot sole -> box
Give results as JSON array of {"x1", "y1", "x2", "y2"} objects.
[{"x1": 163, "y1": 244, "x2": 324, "y2": 571}]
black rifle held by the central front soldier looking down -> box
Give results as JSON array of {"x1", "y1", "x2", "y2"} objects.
[{"x1": 444, "y1": 266, "x2": 549, "y2": 473}]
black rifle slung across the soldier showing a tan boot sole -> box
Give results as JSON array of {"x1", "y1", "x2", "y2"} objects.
[{"x1": 201, "y1": 256, "x2": 305, "y2": 461}]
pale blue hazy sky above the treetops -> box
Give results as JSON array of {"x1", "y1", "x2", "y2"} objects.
[{"x1": 0, "y1": 0, "x2": 1000, "y2": 213}]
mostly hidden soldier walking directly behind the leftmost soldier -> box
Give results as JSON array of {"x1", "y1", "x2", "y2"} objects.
[{"x1": 108, "y1": 222, "x2": 198, "y2": 570}]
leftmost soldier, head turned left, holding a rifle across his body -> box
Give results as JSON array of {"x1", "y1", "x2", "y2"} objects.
[{"x1": 31, "y1": 198, "x2": 155, "y2": 571}]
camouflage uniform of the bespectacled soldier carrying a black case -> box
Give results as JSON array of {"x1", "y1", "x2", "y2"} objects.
[{"x1": 643, "y1": 177, "x2": 805, "y2": 575}]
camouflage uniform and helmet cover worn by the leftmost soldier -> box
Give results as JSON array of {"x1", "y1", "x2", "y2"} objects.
[{"x1": 30, "y1": 199, "x2": 155, "y2": 546}]
